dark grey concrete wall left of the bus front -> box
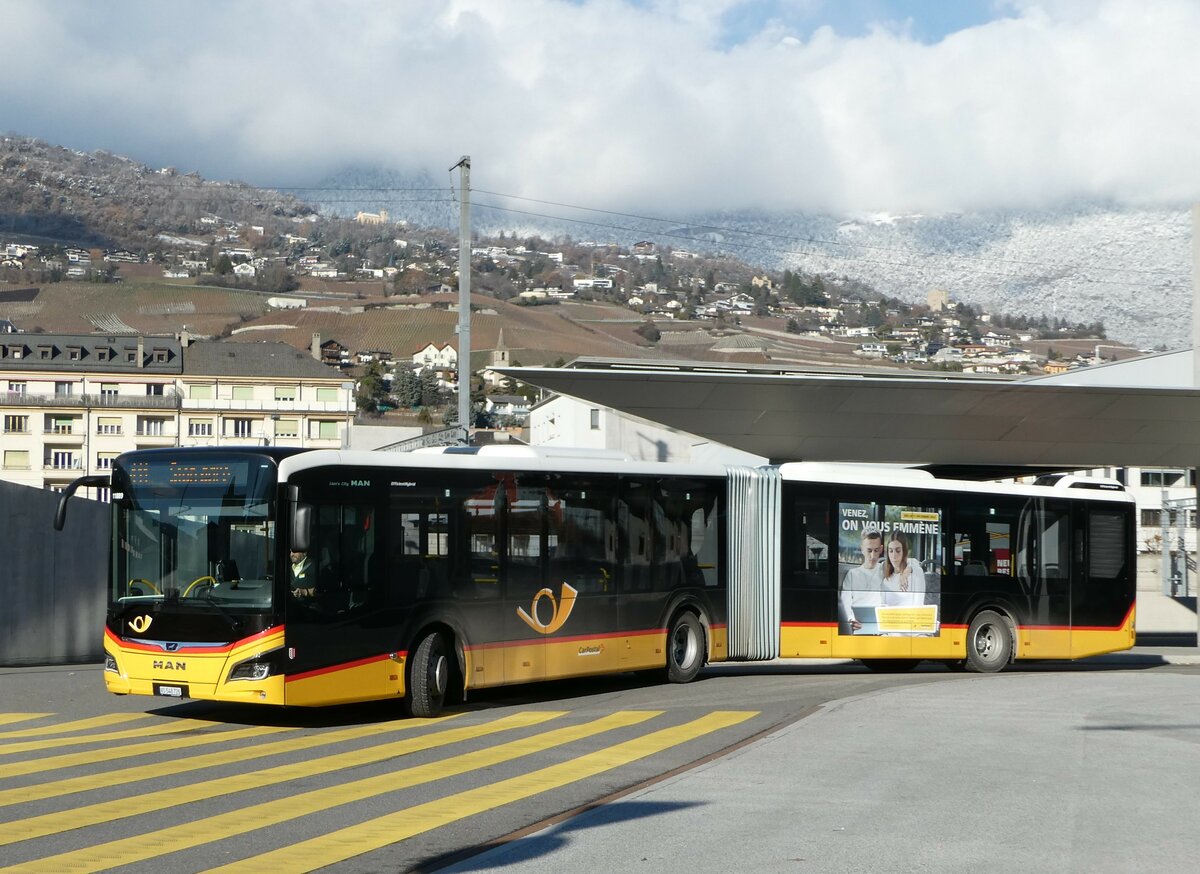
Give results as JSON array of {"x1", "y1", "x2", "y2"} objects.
[{"x1": 0, "y1": 483, "x2": 109, "y2": 666}]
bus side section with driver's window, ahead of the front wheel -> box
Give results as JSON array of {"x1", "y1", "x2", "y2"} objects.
[{"x1": 287, "y1": 487, "x2": 388, "y2": 705}]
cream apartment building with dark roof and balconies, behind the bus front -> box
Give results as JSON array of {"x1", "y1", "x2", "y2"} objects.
[{"x1": 0, "y1": 334, "x2": 354, "y2": 490}]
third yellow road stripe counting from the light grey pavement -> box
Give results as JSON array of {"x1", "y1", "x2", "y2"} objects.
[{"x1": 0, "y1": 713, "x2": 547, "y2": 846}]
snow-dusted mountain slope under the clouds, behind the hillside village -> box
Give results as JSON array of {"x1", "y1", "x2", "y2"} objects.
[{"x1": 309, "y1": 168, "x2": 1192, "y2": 348}]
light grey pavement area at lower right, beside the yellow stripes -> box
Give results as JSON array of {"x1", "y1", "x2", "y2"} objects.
[{"x1": 444, "y1": 662, "x2": 1200, "y2": 874}]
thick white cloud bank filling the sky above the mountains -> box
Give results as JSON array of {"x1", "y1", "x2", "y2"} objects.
[{"x1": 0, "y1": 0, "x2": 1200, "y2": 214}]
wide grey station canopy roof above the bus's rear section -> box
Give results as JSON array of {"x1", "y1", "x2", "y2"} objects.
[{"x1": 497, "y1": 357, "x2": 1200, "y2": 478}]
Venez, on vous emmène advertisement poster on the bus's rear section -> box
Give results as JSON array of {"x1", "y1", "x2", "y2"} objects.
[{"x1": 838, "y1": 502, "x2": 944, "y2": 636}]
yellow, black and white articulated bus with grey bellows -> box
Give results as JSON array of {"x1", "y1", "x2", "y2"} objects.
[{"x1": 56, "y1": 447, "x2": 1135, "y2": 717}]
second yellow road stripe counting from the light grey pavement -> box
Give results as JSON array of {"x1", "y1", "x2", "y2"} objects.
[{"x1": 0, "y1": 711, "x2": 661, "y2": 874}]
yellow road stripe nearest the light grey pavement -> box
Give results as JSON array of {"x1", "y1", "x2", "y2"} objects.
[{"x1": 209, "y1": 711, "x2": 757, "y2": 874}]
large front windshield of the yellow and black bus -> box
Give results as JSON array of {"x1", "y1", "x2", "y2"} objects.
[{"x1": 109, "y1": 453, "x2": 275, "y2": 611}]
